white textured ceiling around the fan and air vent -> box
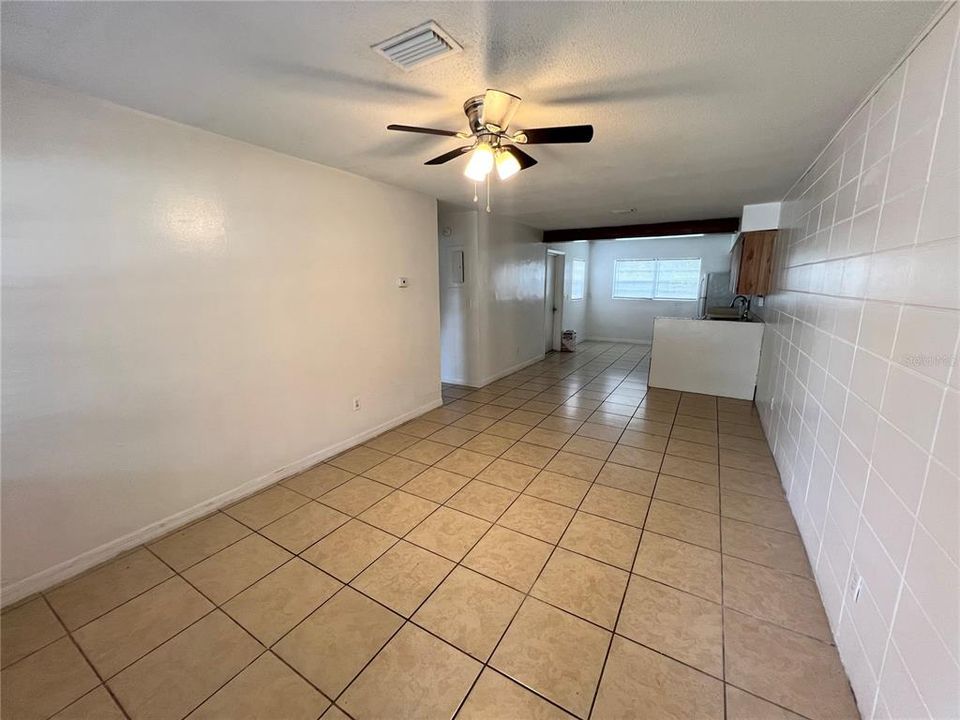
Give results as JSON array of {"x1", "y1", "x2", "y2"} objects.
[{"x1": 2, "y1": 2, "x2": 940, "y2": 228}]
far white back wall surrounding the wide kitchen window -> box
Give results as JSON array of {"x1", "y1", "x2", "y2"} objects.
[{"x1": 587, "y1": 235, "x2": 731, "y2": 343}]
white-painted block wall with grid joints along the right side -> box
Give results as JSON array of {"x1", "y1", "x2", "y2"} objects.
[{"x1": 757, "y1": 5, "x2": 960, "y2": 718}]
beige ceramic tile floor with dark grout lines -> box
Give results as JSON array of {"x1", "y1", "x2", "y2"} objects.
[{"x1": 0, "y1": 343, "x2": 856, "y2": 720}]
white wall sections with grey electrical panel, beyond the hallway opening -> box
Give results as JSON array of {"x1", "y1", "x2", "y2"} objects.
[{"x1": 439, "y1": 203, "x2": 547, "y2": 387}]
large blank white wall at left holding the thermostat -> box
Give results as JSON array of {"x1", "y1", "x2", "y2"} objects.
[{"x1": 2, "y1": 75, "x2": 440, "y2": 601}]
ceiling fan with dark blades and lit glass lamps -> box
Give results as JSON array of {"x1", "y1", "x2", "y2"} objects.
[{"x1": 387, "y1": 90, "x2": 593, "y2": 182}]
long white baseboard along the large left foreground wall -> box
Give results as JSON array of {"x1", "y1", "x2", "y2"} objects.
[{"x1": 0, "y1": 395, "x2": 443, "y2": 607}]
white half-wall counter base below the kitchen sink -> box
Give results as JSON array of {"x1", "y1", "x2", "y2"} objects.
[{"x1": 650, "y1": 318, "x2": 763, "y2": 400}]
